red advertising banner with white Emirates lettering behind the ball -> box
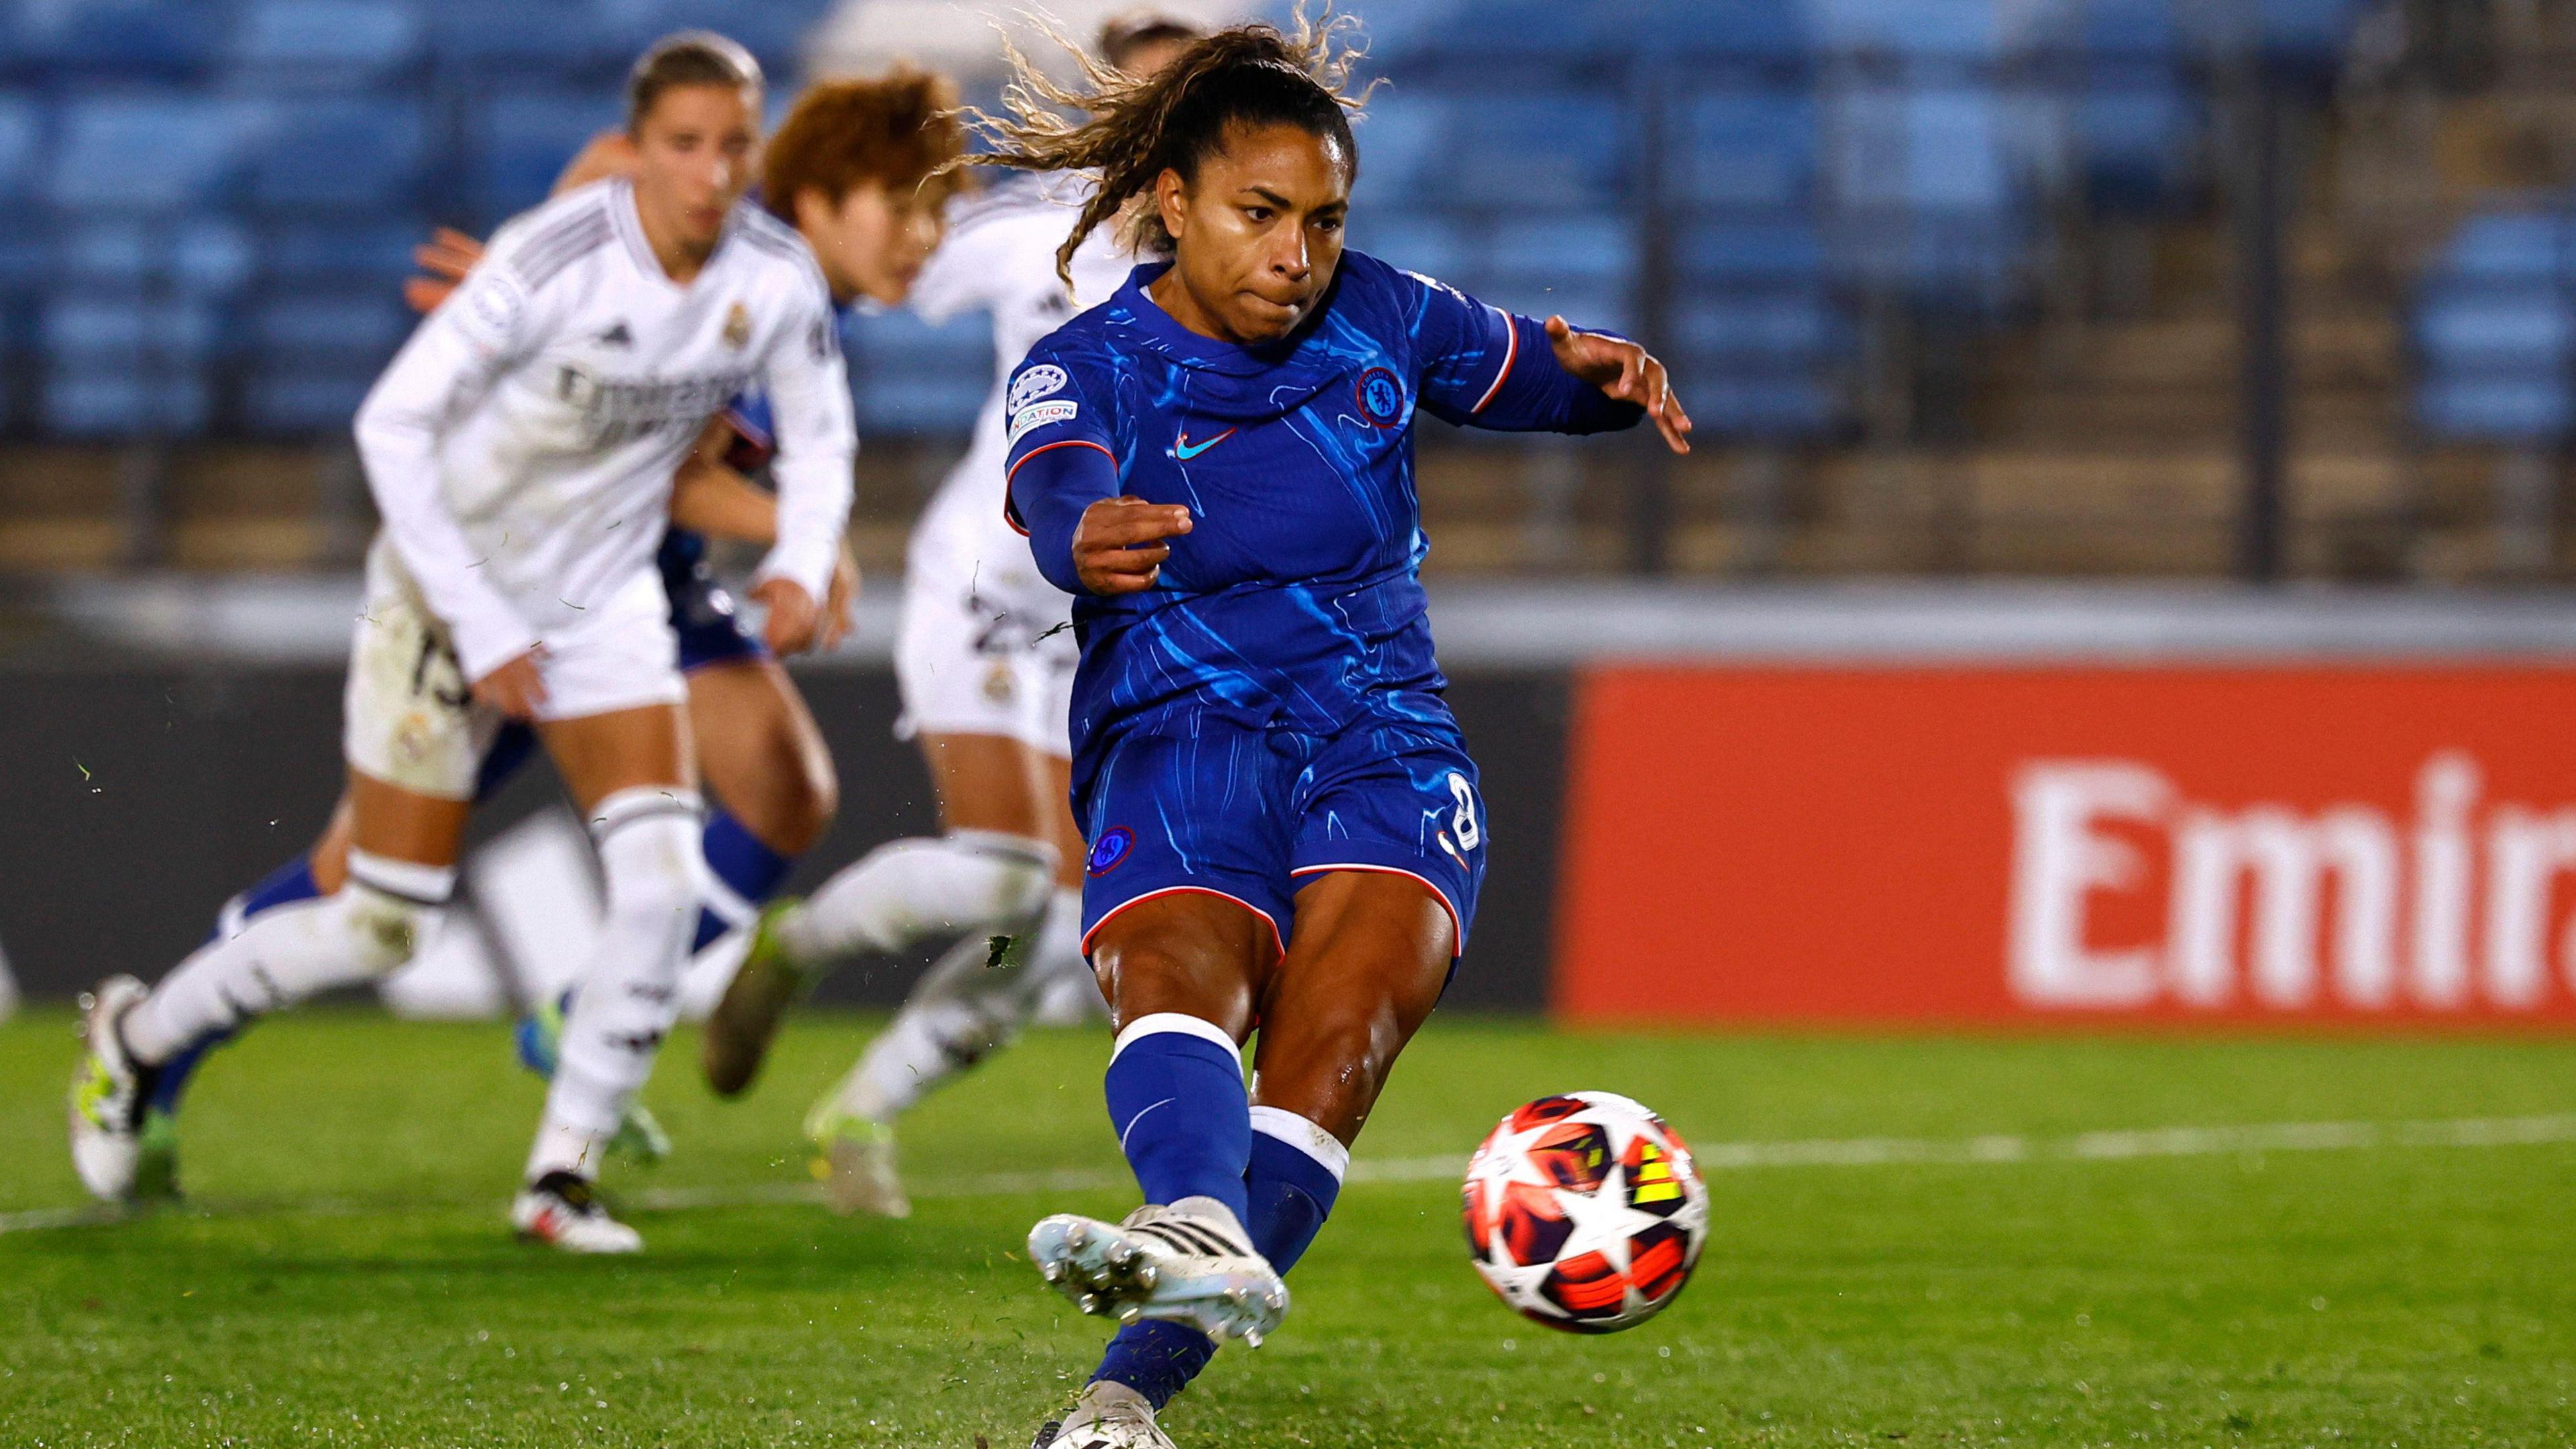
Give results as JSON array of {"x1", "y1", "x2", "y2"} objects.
[{"x1": 1554, "y1": 665, "x2": 2576, "y2": 1026}]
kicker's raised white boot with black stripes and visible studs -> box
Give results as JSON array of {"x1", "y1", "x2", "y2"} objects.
[{"x1": 1028, "y1": 1196, "x2": 1288, "y2": 1348}]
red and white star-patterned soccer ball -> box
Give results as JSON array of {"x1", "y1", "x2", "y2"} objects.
[{"x1": 1466, "y1": 1091, "x2": 1708, "y2": 1333}]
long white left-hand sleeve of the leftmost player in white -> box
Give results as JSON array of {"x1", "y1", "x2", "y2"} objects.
[{"x1": 356, "y1": 250, "x2": 543, "y2": 681}]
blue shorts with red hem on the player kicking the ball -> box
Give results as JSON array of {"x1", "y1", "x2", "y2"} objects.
[{"x1": 1082, "y1": 712, "x2": 1484, "y2": 954}]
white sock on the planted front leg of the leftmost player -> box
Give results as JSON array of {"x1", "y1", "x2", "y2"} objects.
[{"x1": 528, "y1": 786, "x2": 698, "y2": 1181}]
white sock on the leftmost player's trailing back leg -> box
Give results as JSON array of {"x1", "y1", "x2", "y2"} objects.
[{"x1": 121, "y1": 851, "x2": 456, "y2": 1065}]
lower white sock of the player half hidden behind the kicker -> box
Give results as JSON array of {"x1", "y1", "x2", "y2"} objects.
[{"x1": 837, "y1": 890, "x2": 1089, "y2": 1122}]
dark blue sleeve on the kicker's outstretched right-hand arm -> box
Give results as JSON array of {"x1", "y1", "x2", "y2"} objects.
[{"x1": 1396, "y1": 271, "x2": 1646, "y2": 433}]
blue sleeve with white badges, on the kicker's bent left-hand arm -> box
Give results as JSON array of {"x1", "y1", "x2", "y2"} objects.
[{"x1": 1002, "y1": 343, "x2": 1118, "y2": 593}]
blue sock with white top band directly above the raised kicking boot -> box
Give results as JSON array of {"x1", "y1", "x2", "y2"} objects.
[{"x1": 1103, "y1": 1013, "x2": 1252, "y2": 1222}]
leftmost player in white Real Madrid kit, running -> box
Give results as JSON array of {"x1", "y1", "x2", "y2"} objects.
[{"x1": 72, "y1": 34, "x2": 855, "y2": 1253}]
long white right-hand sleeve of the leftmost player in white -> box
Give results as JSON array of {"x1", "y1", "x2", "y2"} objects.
[{"x1": 752, "y1": 276, "x2": 858, "y2": 603}]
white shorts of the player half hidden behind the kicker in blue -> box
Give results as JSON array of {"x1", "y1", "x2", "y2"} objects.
[{"x1": 894, "y1": 492, "x2": 1082, "y2": 758}]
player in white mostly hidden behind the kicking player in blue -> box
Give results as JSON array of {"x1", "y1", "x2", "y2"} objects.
[{"x1": 706, "y1": 10, "x2": 1198, "y2": 1217}]
